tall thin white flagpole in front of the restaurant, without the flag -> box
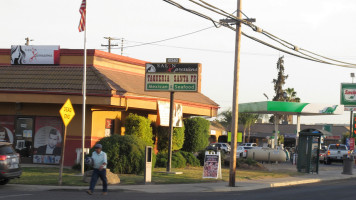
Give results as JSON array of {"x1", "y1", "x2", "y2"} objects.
[{"x1": 81, "y1": 2, "x2": 87, "y2": 176}]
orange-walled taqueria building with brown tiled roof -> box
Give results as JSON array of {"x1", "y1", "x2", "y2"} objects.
[{"x1": 0, "y1": 46, "x2": 218, "y2": 166}]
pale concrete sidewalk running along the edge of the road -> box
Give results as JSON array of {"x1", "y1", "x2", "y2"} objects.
[{"x1": 8, "y1": 170, "x2": 356, "y2": 193}]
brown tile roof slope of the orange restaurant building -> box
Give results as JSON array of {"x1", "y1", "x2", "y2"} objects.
[{"x1": 0, "y1": 65, "x2": 219, "y2": 108}]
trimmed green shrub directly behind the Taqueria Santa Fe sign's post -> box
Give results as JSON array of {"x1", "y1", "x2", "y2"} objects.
[{"x1": 157, "y1": 126, "x2": 184, "y2": 151}]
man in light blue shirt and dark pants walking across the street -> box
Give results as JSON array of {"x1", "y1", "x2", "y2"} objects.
[{"x1": 87, "y1": 144, "x2": 108, "y2": 195}]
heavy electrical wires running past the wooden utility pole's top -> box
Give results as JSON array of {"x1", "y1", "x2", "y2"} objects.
[{"x1": 163, "y1": 0, "x2": 356, "y2": 68}]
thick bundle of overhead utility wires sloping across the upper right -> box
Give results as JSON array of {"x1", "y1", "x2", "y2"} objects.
[{"x1": 163, "y1": 0, "x2": 356, "y2": 68}]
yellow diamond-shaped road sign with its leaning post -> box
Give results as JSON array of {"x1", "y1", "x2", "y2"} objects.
[{"x1": 58, "y1": 99, "x2": 75, "y2": 185}]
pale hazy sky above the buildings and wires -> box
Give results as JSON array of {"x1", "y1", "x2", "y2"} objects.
[{"x1": 0, "y1": 0, "x2": 356, "y2": 124}]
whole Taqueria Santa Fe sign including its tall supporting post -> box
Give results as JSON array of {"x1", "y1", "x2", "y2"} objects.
[{"x1": 145, "y1": 58, "x2": 201, "y2": 172}]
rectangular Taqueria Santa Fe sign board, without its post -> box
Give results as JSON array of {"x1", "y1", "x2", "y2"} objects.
[{"x1": 145, "y1": 63, "x2": 201, "y2": 92}]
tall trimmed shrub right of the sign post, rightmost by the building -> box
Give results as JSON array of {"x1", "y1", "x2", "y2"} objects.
[{"x1": 182, "y1": 117, "x2": 210, "y2": 152}]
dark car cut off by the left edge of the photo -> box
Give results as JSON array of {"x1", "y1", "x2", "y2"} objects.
[{"x1": 0, "y1": 142, "x2": 22, "y2": 185}]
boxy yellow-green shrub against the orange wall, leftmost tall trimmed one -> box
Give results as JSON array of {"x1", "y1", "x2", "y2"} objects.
[{"x1": 125, "y1": 113, "x2": 153, "y2": 145}]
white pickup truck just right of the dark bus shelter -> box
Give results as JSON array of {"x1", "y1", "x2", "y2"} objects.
[{"x1": 325, "y1": 144, "x2": 350, "y2": 165}]
